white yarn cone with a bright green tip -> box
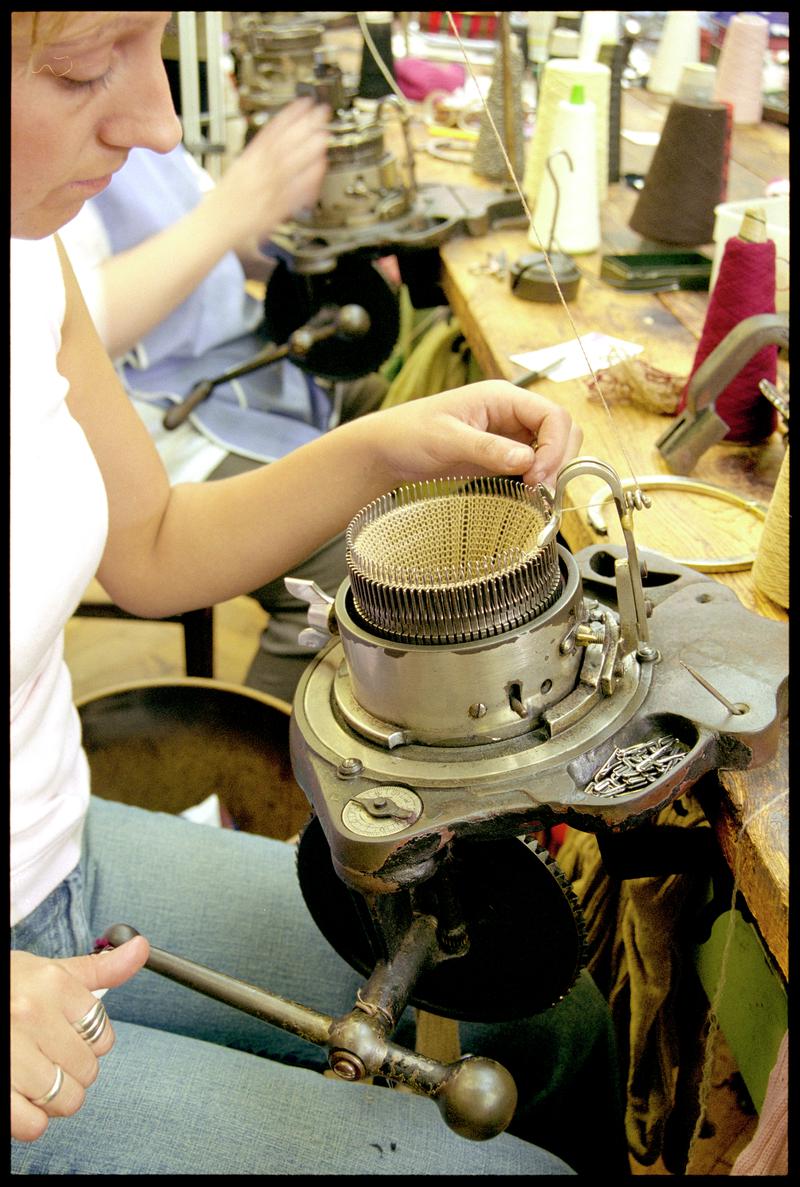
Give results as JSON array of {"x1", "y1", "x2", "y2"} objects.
[{"x1": 528, "y1": 89, "x2": 601, "y2": 255}]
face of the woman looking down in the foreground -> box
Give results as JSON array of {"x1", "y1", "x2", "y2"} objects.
[{"x1": 11, "y1": 12, "x2": 180, "y2": 239}]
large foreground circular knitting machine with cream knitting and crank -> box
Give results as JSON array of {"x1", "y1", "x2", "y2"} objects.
[{"x1": 107, "y1": 458, "x2": 788, "y2": 1140}]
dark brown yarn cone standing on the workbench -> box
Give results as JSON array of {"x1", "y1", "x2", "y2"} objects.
[{"x1": 629, "y1": 100, "x2": 728, "y2": 247}]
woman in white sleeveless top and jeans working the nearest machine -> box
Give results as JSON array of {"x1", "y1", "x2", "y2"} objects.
[{"x1": 11, "y1": 12, "x2": 609, "y2": 1174}]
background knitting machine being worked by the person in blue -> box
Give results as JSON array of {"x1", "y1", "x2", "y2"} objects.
[{"x1": 254, "y1": 43, "x2": 523, "y2": 365}]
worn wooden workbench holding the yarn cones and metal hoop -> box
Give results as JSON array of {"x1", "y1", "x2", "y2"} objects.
[{"x1": 413, "y1": 90, "x2": 788, "y2": 976}]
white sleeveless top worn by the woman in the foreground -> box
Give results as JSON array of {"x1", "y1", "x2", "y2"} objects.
[{"x1": 9, "y1": 236, "x2": 108, "y2": 925}]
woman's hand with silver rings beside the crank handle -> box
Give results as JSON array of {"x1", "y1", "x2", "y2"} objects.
[{"x1": 11, "y1": 935, "x2": 150, "y2": 1142}]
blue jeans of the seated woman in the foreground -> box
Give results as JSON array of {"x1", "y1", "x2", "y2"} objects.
[{"x1": 11, "y1": 798, "x2": 622, "y2": 1175}]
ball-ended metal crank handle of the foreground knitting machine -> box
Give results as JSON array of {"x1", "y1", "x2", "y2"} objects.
[{"x1": 102, "y1": 916, "x2": 516, "y2": 1141}]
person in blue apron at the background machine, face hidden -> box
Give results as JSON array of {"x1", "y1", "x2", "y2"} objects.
[{"x1": 61, "y1": 101, "x2": 388, "y2": 702}]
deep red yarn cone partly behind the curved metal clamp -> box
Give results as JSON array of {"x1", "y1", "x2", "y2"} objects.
[{"x1": 678, "y1": 236, "x2": 777, "y2": 445}]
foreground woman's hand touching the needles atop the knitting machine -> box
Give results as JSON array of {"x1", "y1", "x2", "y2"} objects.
[{"x1": 354, "y1": 380, "x2": 583, "y2": 487}]
